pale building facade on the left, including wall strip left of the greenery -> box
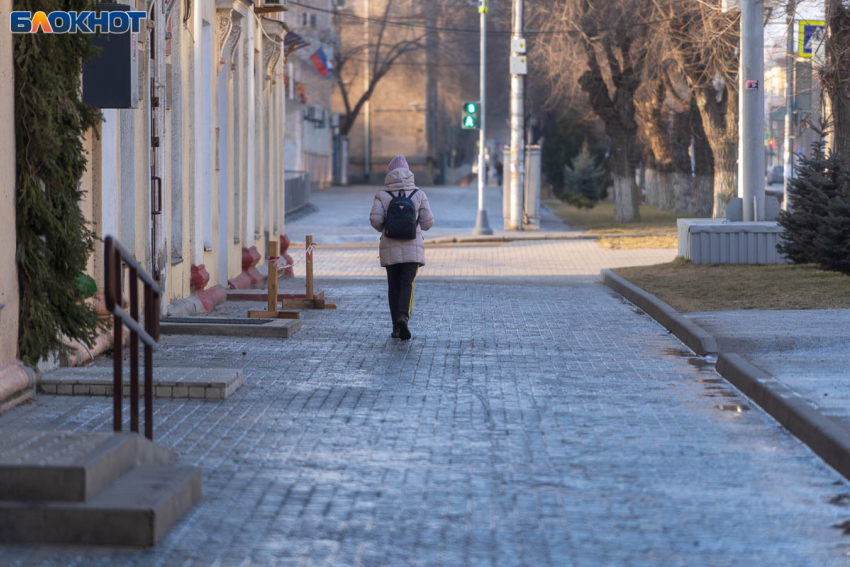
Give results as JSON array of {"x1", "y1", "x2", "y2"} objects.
[{"x1": 0, "y1": 0, "x2": 296, "y2": 404}]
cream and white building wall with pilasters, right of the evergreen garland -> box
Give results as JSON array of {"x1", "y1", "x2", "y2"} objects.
[{"x1": 65, "y1": 0, "x2": 286, "y2": 362}]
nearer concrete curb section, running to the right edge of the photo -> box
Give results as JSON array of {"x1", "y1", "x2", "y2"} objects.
[{"x1": 715, "y1": 353, "x2": 850, "y2": 478}]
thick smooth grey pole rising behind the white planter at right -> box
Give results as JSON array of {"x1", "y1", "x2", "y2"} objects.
[{"x1": 738, "y1": 0, "x2": 764, "y2": 222}]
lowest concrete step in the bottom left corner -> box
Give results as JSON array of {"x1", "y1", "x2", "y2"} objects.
[{"x1": 0, "y1": 466, "x2": 201, "y2": 546}]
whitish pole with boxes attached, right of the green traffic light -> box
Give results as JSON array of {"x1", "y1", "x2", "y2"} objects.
[{"x1": 505, "y1": 0, "x2": 525, "y2": 230}]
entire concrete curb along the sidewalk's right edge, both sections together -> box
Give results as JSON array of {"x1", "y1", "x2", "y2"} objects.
[{"x1": 602, "y1": 270, "x2": 850, "y2": 479}]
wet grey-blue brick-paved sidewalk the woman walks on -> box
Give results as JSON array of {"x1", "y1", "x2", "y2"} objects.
[{"x1": 0, "y1": 270, "x2": 850, "y2": 567}]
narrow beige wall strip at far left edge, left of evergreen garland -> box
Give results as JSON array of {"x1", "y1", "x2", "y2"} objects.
[{"x1": 0, "y1": 0, "x2": 18, "y2": 366}]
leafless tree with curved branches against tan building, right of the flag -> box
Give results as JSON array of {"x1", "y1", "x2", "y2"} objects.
[{"x1": 334, "y1": 0, "x2": 426, "y2": 135}]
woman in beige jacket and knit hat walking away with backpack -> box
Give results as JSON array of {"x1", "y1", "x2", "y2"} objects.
[{"x1": 369, "y1": 155, "x2": 434, "y2": 341}]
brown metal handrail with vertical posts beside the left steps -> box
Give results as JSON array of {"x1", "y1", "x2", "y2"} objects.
[{"x1": 103, "y1": 236, "x2": 161, "y2": 440}]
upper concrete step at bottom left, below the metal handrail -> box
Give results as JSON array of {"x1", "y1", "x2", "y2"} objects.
[{"x1": 0, "y1": 429, "x2": 177, "y2": 502}]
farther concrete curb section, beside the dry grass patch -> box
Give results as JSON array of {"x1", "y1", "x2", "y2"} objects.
[{"x1": 602, "y1": 270, "x2": 718, "y2": 356}]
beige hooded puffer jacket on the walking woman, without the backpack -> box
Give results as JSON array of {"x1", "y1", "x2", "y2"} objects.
[{"x1": 369, "y1": 168, "x2": 434, "y2": 266}]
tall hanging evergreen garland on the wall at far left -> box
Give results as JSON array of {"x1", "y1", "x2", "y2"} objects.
[{"x1": 13, "y1": 0, "x2": 101, "y2": 365}]
